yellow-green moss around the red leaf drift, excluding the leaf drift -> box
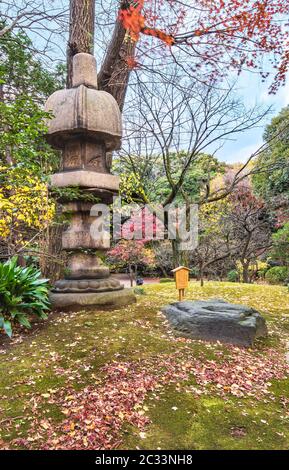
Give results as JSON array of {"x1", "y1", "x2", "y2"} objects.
[{"x1": 0, "y1": 282, "x2": 289, "y2": 449}]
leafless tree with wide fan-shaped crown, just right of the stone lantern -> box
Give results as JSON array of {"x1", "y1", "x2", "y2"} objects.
[{"x1": 117, "y1": 66, "x2": 266, "y2": 265}]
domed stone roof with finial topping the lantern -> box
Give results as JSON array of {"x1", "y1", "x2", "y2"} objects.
[{"x1": 45, "y1": 53, "x2": 122, "y2": 151}]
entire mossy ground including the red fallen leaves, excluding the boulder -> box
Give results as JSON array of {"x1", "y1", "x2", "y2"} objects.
[{"x1": 0, "y1": 282, "x2": 289, "y2": 449}]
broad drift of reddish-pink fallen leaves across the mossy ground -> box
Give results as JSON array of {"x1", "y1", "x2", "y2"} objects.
[{"x1": 5, "y1": 343, "x2": 288, "y2": 450}]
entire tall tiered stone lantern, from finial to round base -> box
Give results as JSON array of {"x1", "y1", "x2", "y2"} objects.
[{"x1": 45, "y1": 53, "x2": 135, "y2": 310}]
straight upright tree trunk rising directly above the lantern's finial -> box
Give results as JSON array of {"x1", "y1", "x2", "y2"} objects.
[{"x1": 67, "y1": 0, "x2": 95, "y2": 88}]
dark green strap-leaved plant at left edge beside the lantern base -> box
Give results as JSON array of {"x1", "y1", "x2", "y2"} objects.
[{"x1": 0, "y1": 257, "x2": 49, "y2": 337}]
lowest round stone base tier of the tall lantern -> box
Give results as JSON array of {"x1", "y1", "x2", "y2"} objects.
[{"x1": 50, "y1": 289, "x2": 136, "y2": 312}]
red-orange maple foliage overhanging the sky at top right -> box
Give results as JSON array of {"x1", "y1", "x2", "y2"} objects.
[{"x1": 119, "y1": 0, "x2": 289, "y2": 92}]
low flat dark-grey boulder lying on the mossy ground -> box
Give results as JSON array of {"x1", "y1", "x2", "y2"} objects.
[{"x1": 162, "y1": 299, "x2": 268, "y2": 347}]
